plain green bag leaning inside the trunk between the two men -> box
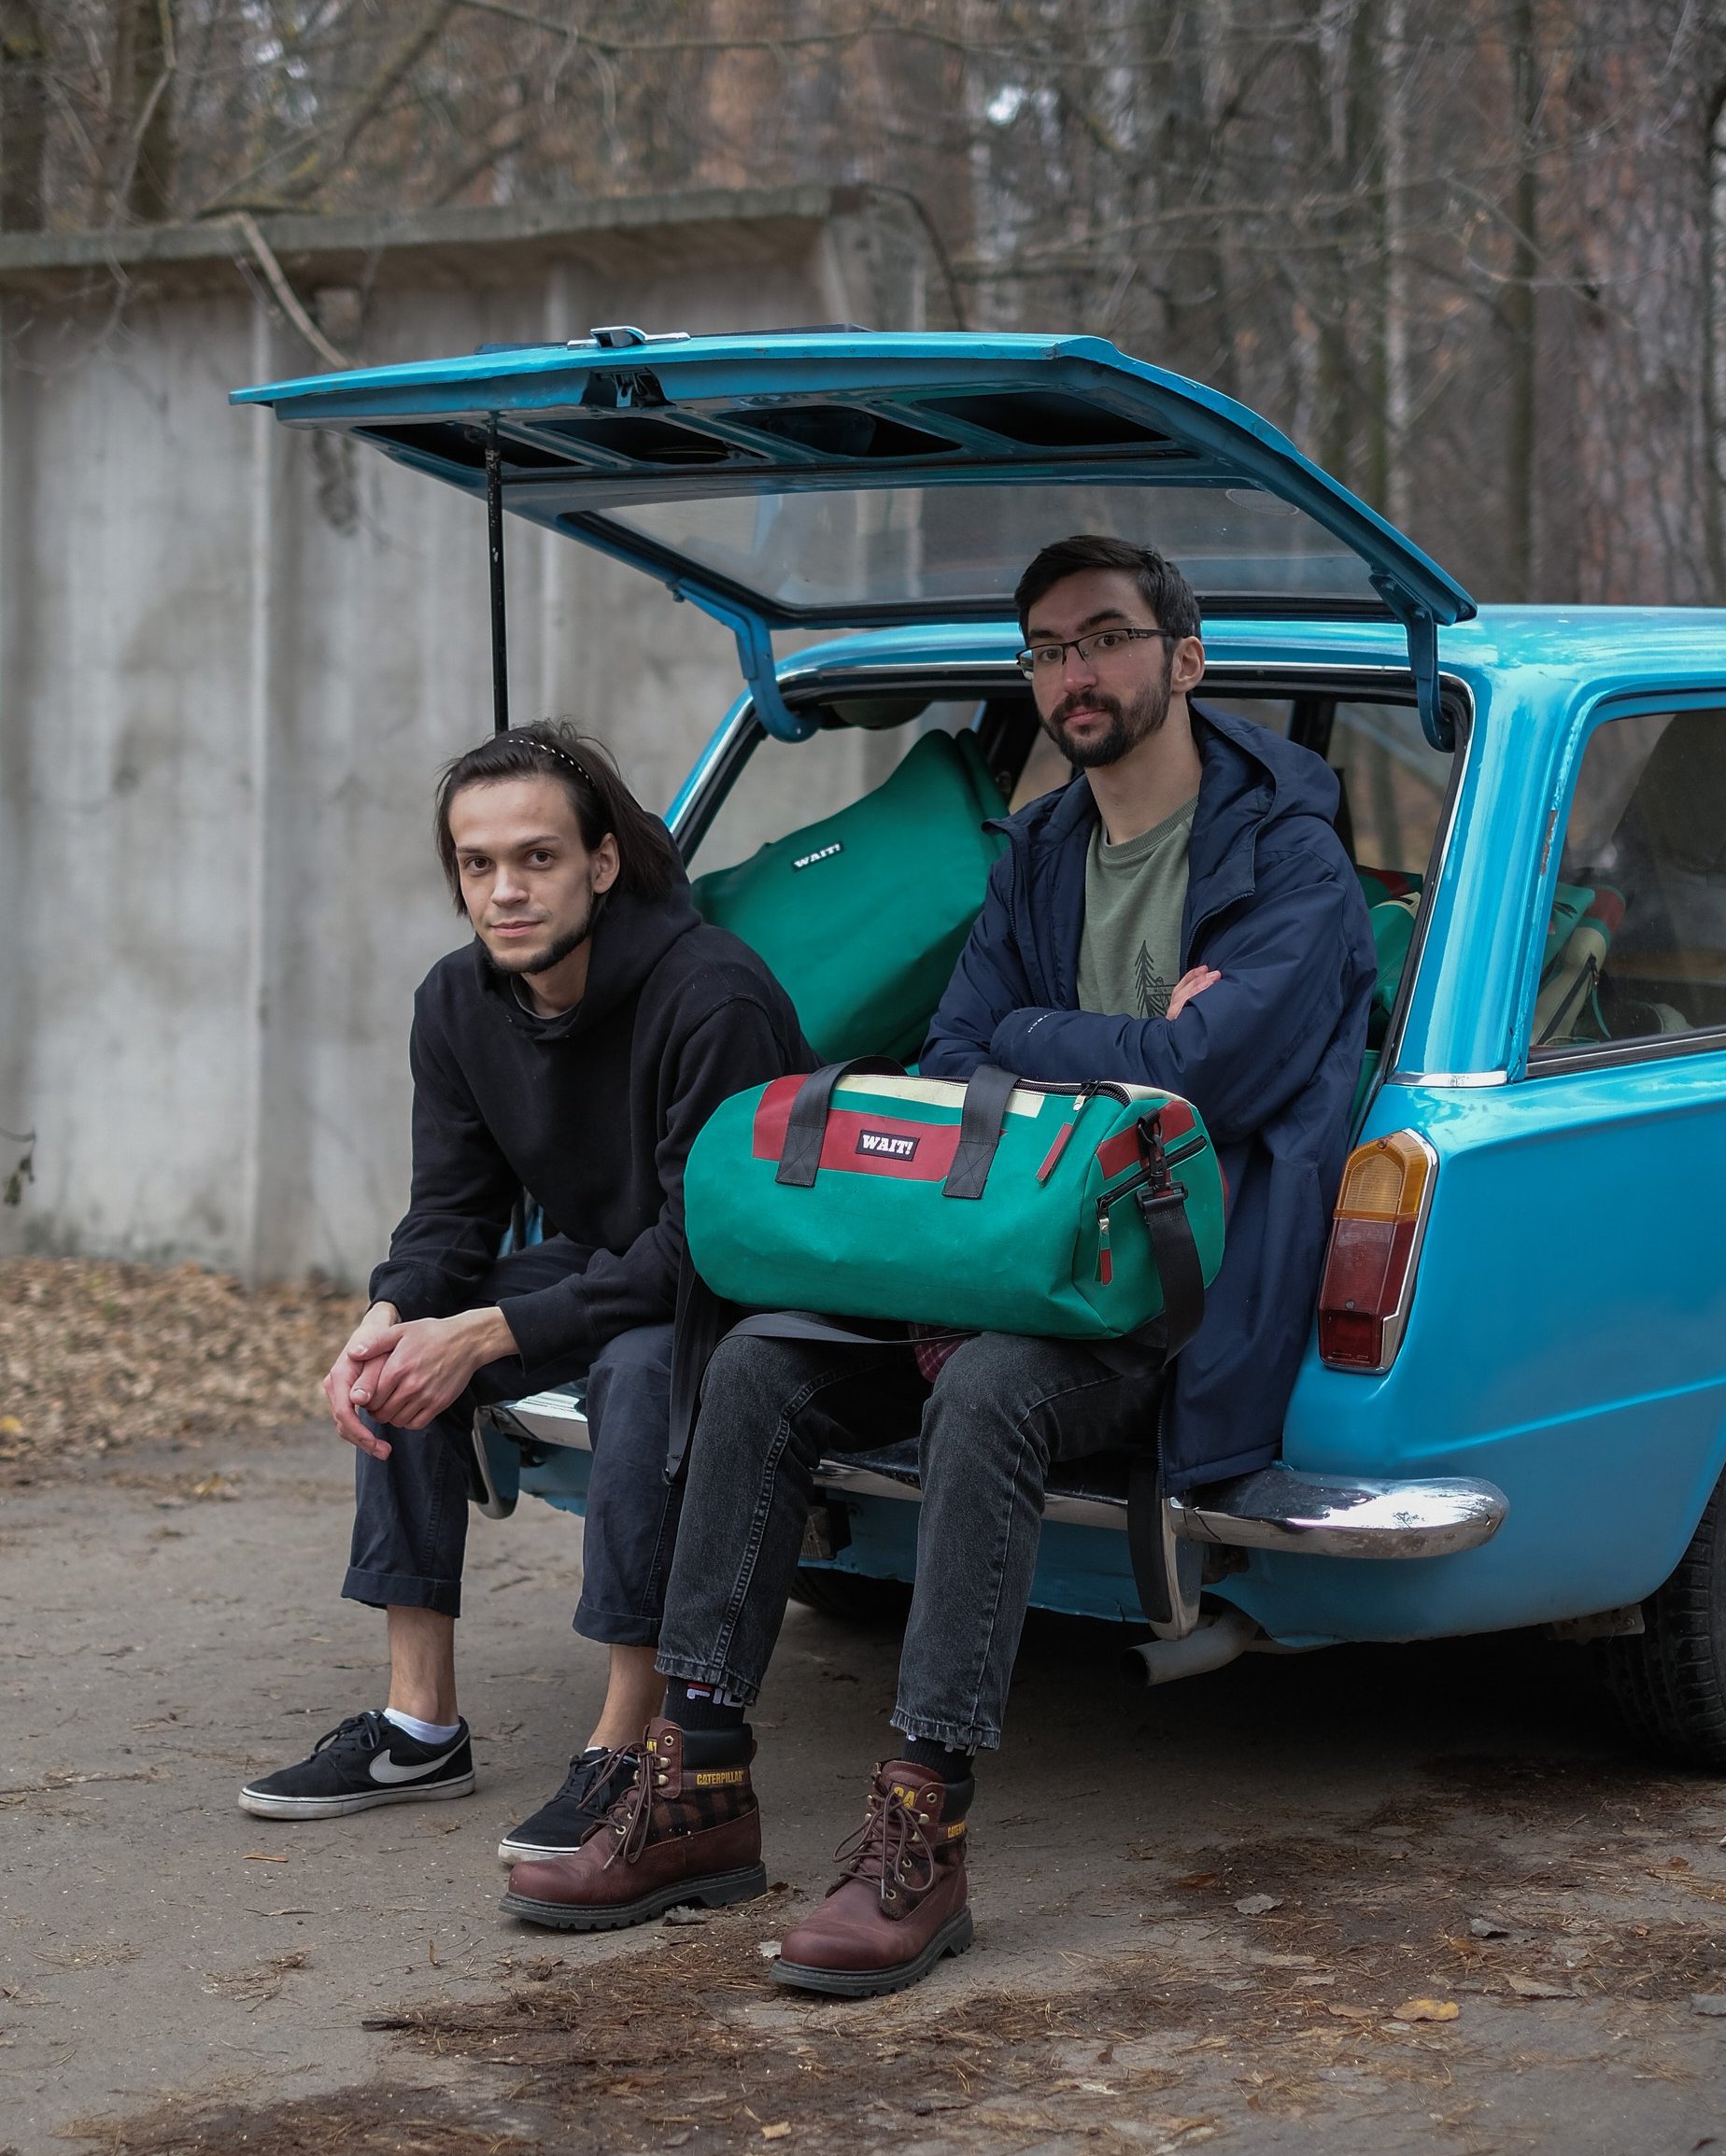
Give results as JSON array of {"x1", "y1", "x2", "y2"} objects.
[{"x1": 693, "y1": 733, "x2": 1008, "y2": 1059}]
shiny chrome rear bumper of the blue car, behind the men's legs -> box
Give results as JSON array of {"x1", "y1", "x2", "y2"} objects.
[{"x1": 486, "y1": 1393, "x2": 1510, "y2": 1558}]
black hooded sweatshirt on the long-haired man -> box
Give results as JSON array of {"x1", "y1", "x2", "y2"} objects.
[{"x1": 371, "y1": 880, "x2": 815, "y2": 1369}]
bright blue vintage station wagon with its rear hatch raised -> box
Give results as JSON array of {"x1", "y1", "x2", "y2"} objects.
[{"x1": 237, "y1": 328, "x2": 1726, "y2": 1766}]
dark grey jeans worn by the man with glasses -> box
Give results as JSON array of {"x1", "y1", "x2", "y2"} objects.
[{"x1": 658, "y1": 1332, "x2": 1163, "y2": 1751}]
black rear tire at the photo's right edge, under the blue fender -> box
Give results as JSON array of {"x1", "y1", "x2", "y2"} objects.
[{"x1": 1601, "y1": 1479, "x2": 1726, "y2": 1772}]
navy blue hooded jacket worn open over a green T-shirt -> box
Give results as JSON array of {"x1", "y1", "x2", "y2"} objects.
[{"x1": 921, "y1": 705, "x2": 1374, "y2": 1490}]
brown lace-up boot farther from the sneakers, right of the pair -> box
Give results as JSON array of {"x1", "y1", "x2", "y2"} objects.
[{"x1": 772, "y1": 1759, "x2": 971, "y2": 1998}]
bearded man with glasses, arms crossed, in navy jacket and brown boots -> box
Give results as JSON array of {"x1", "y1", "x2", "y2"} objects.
[{"x1": 505, "y1": 537, "x2": 1374, "y2": 1996}]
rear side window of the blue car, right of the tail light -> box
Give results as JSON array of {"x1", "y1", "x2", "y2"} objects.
[{"x1": 1530, "y1": 707, "x2": 1726, "y2": 1063}]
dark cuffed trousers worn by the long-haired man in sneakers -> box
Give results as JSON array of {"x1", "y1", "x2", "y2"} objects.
[{"x1": 341, "y1": 1240, "x2": 682, "y2": 1647}]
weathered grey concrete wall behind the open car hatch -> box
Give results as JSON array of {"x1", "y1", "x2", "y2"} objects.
[{"x1": 0, "y1": 190, "x2": 921, "y2": 1281}]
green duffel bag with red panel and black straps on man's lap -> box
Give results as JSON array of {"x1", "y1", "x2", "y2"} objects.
[{"x1": 684, "y1": 1059, "x2": 1224, "y2": 1356}]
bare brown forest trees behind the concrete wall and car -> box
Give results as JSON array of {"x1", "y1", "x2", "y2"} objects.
[{"x1": 0, "y1": 0, "x2": 1726, "y2": 604}]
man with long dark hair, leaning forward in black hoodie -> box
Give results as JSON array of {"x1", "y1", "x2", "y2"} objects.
[{"x1": 239, "y1": 725, "x2": 813, "y2": 1861}]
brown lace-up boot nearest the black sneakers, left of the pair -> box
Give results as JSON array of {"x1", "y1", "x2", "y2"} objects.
[{"x1": 499, "y1": 1716, "x2": 768, "y2": 1932}]
